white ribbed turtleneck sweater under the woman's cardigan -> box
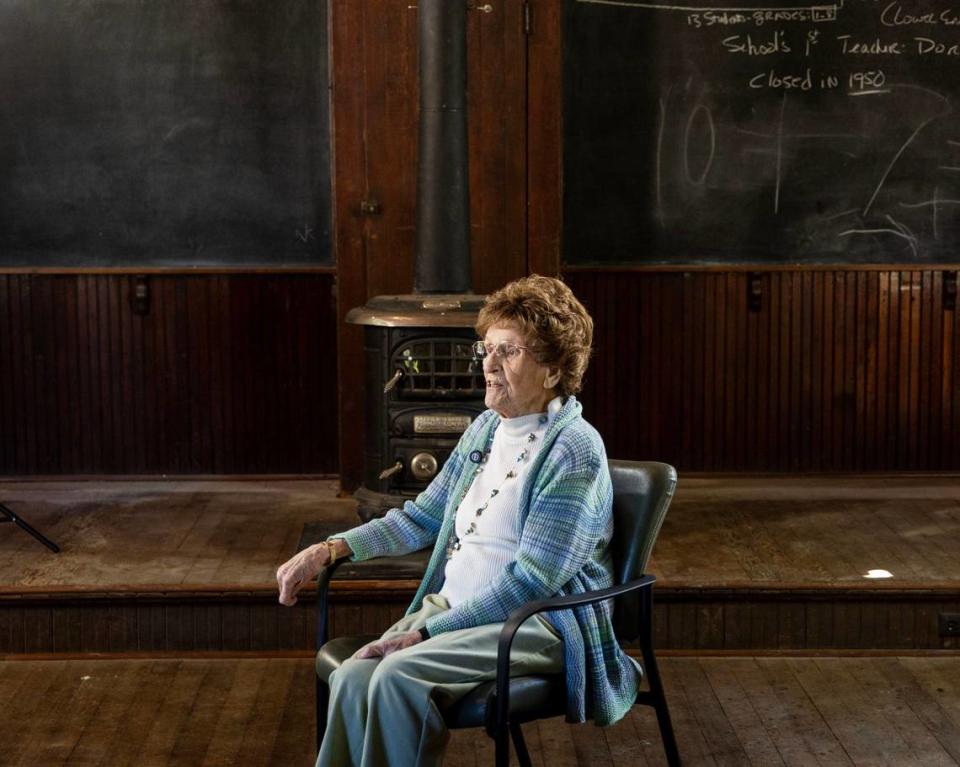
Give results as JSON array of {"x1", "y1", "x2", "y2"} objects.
[{"x1": 440, "y1": 397, "x2": 563, "y2": 607}]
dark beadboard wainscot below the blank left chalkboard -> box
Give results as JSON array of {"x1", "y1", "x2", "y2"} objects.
[{"x1": 0, "y1": 273, "x2": 338, "y2": 475}]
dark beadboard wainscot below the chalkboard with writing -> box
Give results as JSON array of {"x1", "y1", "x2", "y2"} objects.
[{"x1": 565, "y1": 269, "x2": 960, "y2": 471}]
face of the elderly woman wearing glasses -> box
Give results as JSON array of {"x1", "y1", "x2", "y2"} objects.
[{"x1": 483, "y1": 325, "x2": 559, "y2": 418}]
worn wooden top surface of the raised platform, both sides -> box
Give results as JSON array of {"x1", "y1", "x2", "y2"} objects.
[{"x1": 0, "y1": 476, "x2": 960, "y2": 592}]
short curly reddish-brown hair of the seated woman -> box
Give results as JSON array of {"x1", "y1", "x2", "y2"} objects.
[{"x1": 476, "y1": 274, "x2": 593, "y2": 396}]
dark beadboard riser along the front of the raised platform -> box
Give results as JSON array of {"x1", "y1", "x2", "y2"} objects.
[{"x1": 0, "y1": 586, "x2": 960, "y2": 656}]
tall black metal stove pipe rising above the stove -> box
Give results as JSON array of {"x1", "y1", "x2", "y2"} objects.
[{"x1": 413, "y1": 0, "x2": 471, "y2": 293}]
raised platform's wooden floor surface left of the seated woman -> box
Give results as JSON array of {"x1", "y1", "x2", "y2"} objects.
[{"x1": 0, "y1": 481, "x2": 356, "y2": 589}]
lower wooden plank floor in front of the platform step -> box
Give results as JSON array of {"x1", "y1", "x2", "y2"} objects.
[{"x1": 0, "y1": 657, "x2": 960, "y2": 767}]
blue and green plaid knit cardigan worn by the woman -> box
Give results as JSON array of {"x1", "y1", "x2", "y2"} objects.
[{"x1": 337, "y1": 397, "x2": 638, "y2": 725}]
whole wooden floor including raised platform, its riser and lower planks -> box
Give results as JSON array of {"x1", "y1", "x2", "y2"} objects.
[{"x1": 0, "y1": 476, "x2": 960, "y2": 767}]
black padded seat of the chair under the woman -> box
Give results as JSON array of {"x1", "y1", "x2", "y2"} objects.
[{"x1": 316, "y1": 634, "x2": 567, "y2": 729}]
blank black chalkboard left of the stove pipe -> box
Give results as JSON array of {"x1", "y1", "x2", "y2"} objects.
[{"x1": 0, "y1": 0, "x2": 331, "y2": 267}]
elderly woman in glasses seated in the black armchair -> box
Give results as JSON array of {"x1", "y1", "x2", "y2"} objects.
[{"x1": 277, "y1": 276, "x2": 638, "y2": 767}]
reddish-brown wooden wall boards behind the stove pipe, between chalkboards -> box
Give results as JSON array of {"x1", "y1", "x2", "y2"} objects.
[{"x1": 330, "y1": 0, "x2": 532, "y2": 490}]
